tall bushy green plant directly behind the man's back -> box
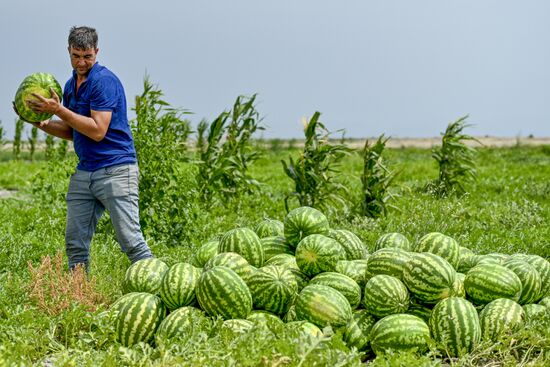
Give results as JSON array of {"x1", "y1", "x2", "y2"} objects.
[{"x1": 132, "y1": 76, "x2": 194, "y2": 243}]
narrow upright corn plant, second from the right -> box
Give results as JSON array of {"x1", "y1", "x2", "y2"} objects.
[{"x1": 359, "y1": 135, "x2": 397, "y2": 218}]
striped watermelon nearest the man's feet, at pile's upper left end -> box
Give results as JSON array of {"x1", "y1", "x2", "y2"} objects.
[{"x1": 122, "y1": 258, "x2": 168, "y2": 294}]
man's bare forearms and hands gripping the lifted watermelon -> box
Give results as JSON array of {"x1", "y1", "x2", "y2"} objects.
[{"x1": 27, "y1": 90, "x2": 112, "y2": 141}]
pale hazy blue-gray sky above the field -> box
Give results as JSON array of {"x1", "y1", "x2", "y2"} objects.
[{"x1": 0, "y1": 0, "x2": 550, "y2": 139}]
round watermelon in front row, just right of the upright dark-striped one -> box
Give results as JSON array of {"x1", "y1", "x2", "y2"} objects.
[{"x1": 479, "y1": 298, "x2": 525, "y2": 341}]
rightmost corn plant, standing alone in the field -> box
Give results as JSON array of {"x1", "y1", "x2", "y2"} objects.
[{"x1": 431, "y1": 115, "x2": 479, "y2": 196}]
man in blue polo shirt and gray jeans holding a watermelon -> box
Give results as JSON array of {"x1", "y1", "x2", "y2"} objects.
[{"x1": 16, "y1": 27, "x2": 152, "y2": 269}]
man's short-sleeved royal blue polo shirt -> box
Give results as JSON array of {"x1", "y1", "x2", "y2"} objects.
[{"x1": 63, "y1": 62, "x2": 137, "y2": 171}]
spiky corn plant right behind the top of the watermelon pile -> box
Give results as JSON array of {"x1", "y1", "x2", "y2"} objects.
[{"x1": 281, "y1": 111, "x2": 350, "y2": 211}]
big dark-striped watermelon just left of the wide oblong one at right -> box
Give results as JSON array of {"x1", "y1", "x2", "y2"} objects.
[{"x1": 403, "y1": 252, "x2": 456, "y2": 304}]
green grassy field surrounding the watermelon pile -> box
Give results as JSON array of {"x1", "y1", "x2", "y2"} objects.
[{"x1": 0, "y1": 144, "x2": 550, "y2": 366}]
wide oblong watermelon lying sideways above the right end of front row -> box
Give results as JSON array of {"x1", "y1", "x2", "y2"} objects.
[{"x1": 464, "y1": 264, "x2": 522, "y2": 305}]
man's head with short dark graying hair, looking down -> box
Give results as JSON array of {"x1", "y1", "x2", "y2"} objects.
[{"x1": 69, "y1": 27, "x2": 99, "y2": 76}]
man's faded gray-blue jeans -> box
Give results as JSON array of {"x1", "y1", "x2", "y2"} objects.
[{"x1": 65, "y1": 164, "x2": 152, "y2": 269}]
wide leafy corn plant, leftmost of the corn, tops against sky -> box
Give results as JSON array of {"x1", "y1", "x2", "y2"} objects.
[{"x1": 196, "y1": 95, "x2": 263, "y2": 203}]
